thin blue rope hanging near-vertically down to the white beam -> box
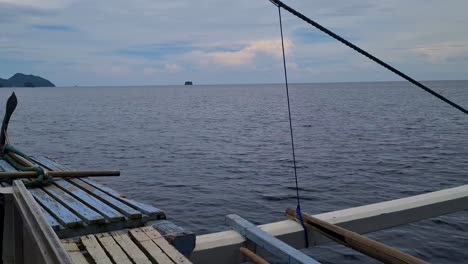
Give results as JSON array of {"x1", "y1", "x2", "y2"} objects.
[{"x1": 278, "y1": 6, "x2": 309, "y2": 248}]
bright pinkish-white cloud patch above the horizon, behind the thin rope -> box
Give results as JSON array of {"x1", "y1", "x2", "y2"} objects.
[{"x1": 193, "y1": 39, "x2": 293, "y2": 66}]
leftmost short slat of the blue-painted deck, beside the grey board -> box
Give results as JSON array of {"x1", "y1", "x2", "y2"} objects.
[{"x1": 29, "y1": 189, "x2": 83, "y2": 227}]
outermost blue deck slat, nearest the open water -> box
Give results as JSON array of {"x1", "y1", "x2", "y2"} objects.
[{"x1": 32, "y1": 156, "x2": 166, "y2": 219}]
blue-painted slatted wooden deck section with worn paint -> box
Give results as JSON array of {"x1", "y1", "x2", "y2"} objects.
[{"x1": 0, "y1": 156, "x2": 166, "y2": 238}]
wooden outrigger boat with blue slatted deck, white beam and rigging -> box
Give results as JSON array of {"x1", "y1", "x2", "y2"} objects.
[{"x1": 0, "y1": 0, "x2": 468, "y2": 264}]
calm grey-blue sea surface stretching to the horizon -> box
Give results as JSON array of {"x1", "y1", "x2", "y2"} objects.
[{"x1": 0, "y1": 81, "x2": 468, "y2": 263}]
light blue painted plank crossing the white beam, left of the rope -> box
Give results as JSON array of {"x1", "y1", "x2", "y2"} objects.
[{"x1": 226, "y1": 214, "x2": 319, "y2": 264}]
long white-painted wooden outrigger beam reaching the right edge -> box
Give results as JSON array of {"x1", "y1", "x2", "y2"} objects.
[{"x1": 190, "y1": 185, "x2": 468, "y2": 264}]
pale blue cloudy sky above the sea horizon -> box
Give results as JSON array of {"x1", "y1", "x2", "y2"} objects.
[{"x1": 0, "y1": 0, "x2": 468, "y2": 86}]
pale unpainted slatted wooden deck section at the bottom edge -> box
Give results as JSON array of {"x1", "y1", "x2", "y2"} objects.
[{"x1": 62, "y1": 227, "x2": 191, "y2": 264}]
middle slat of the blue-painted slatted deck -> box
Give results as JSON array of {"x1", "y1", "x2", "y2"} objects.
[{"x1": 55, "y1": 180, "x2": 125, "y2": 222}]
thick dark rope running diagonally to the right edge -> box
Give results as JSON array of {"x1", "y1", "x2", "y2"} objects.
[{"x1": 270, "y1": 0, "x2": 468, "y2": 115}]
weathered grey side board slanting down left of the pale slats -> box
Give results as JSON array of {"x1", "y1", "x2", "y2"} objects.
[{"x1": 13, "y1": 181, "x2": 72, "y2": 264}]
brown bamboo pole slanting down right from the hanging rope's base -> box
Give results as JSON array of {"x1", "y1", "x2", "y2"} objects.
[{"x1": 286, "y1": 208, "x2": 426, "y2": 264}]
